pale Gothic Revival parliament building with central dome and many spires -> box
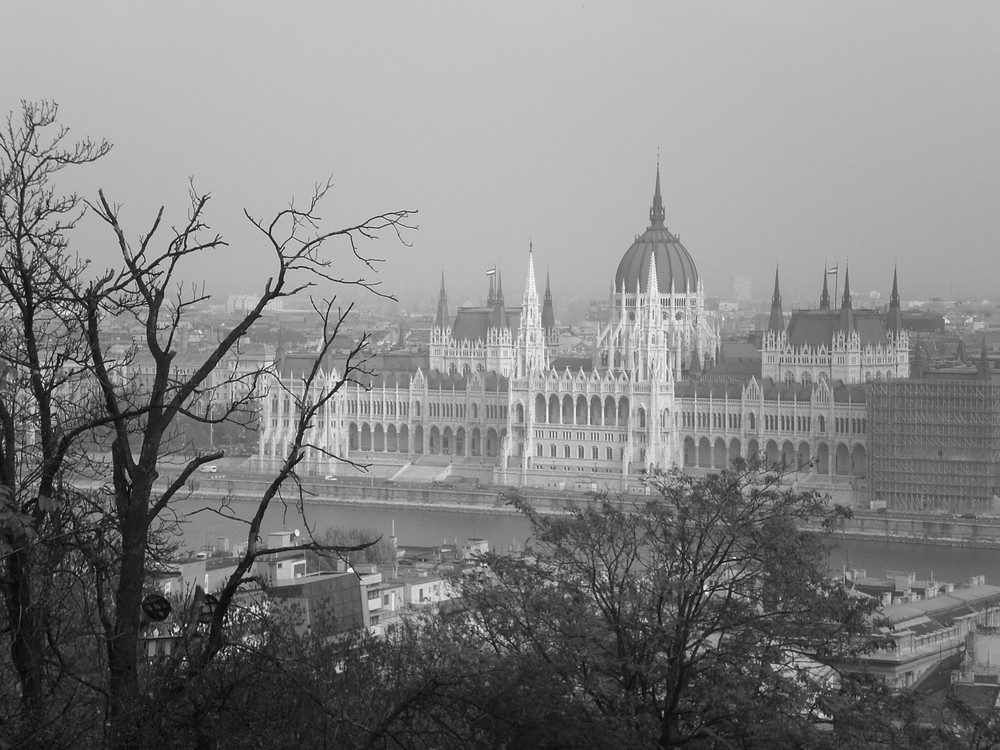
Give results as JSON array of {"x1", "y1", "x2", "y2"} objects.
[{"x1": 258, "y1": 168, "x2": 910, "y2": 490}]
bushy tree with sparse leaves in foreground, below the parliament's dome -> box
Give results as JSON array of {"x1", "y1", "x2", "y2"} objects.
[{"x1": 344, "y1": 463, "x2": 892, "y2": 747}]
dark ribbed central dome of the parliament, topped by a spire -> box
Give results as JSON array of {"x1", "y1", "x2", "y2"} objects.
[{"x1": 615, "y1": 166, "x2": 698, "y2": 294}]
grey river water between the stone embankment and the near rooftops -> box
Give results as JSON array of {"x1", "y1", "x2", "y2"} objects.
[{"x1": 175, "y1": 500, "x2": 1000, "y2": 584}]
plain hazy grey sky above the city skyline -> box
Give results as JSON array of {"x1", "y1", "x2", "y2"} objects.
[{"x1": 0, "y1": 0, "x2": 1000, "y2": 309}]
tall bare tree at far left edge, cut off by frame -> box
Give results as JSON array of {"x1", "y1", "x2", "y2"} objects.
[{"x1": 0, "y1": 102, "x2": 110, "y2": 748}]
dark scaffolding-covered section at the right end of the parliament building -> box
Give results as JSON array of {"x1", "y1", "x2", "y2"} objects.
[{"x1": 868, "y1": 378, "x2": 1000, "y2": 513}]
